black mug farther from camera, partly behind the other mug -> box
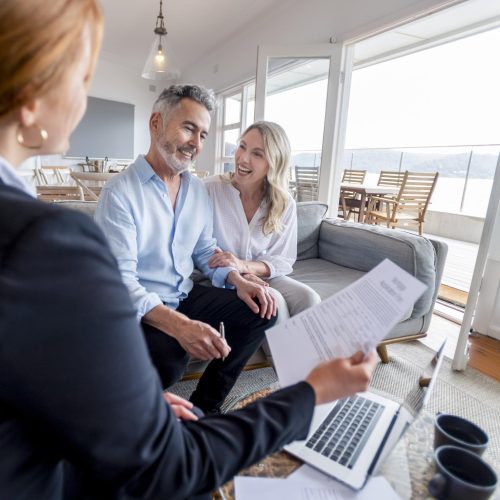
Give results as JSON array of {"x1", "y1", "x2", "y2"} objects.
[{"x1": 434, "y1": 413, "x2": 489, "y2": 455}]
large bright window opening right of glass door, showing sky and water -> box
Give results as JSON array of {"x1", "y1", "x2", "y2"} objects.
[{"x1": 343, "y1": 28, "x2": 500, "y2": 217}]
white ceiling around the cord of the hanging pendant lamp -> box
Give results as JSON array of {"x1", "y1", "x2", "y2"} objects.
[{"x1": 101, "y1": 0, "x2": 287, "y2": 71}]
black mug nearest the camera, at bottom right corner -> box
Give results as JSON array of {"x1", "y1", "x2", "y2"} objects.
[{"x1": 429, "y1": 446, "x2": 498, "y2": 500}]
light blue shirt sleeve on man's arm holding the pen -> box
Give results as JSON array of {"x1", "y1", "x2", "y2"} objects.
[{"x1": 95, "y1": 189, "x2": 162, "y2": 321}]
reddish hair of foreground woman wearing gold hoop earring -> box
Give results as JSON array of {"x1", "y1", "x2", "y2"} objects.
[{"x1": 0, "y1": 0, "x2": 103, "y2": 116}]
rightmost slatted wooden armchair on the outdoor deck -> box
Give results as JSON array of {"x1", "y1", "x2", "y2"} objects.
[{"x1": 367, "y1": 171, "x2": 439, "y2": 235}]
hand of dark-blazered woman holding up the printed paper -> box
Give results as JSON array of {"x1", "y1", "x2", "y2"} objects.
[{"x1": 306, "y1": 352, "x2": 377, "y2": 404}]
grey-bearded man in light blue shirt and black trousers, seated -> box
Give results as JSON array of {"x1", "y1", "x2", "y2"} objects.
[{"x1": 96, "y1": 85, "x2": 276, "y2": 413}]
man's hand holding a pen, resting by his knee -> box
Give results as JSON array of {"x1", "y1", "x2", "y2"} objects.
[{"x1": 172, "y1": 318, "x2": 231, "y2": 360}]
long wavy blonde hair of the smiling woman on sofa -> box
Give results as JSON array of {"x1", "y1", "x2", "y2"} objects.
[{"x1": 231, "y1": 121, "x2": 291, "y2": 235}]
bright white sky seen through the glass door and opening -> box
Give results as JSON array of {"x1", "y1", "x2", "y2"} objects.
[{"x1": 266, "y1": 24, "x2": 500, "y2": 151}]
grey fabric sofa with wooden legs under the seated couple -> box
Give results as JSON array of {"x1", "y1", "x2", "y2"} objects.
[{"x1": 56, "y1": 201, "x2": 447, "y2": 364}]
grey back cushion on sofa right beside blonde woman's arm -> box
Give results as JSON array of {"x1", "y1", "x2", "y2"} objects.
[{"x1": 297, "y1": 201, "x2": 328, "y2": 260}]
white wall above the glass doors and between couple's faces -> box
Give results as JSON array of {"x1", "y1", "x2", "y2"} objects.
[{"x1": 182, "y1": 0, "x2": 452, "y2": 171}]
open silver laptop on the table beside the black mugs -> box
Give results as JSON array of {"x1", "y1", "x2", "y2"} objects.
[{"x1": 285, "y1": 341, "x2": 446, "y2": 489}]
